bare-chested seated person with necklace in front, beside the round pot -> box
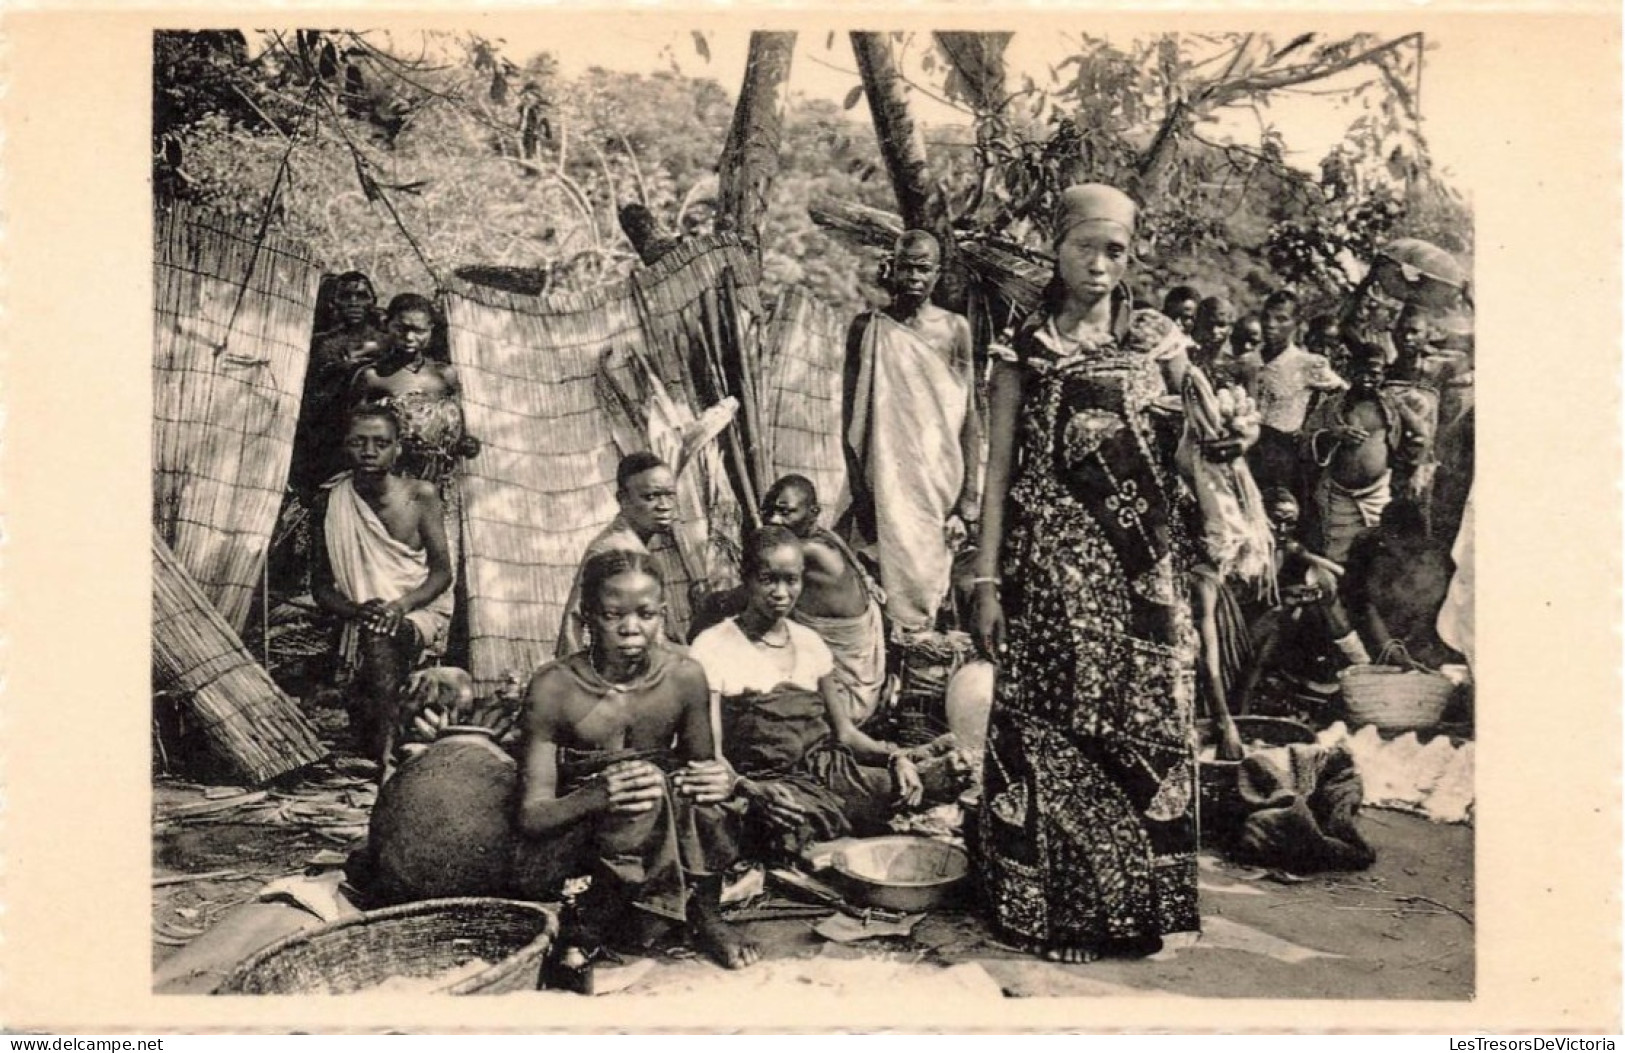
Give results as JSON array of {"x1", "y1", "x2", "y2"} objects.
[{"x1": 514, "y1": 549, "x2": 761, "y2": 969}]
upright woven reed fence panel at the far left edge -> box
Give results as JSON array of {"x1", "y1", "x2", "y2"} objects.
[{"x1": 153, "y1": 208, "x2": 322, "y2": 632}]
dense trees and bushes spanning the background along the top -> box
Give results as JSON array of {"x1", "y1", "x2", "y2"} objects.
[{"x1": 153, "y1": 33, "x2": 1471, "y2": 320}]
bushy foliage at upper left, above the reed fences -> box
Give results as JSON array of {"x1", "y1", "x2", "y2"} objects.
[{"x1": 154, "y1": 33, "x2": 889, "y2": 310}]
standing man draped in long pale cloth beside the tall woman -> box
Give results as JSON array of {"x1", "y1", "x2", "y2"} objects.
[{"x1": 840, "y1": 231, "x2": 983, "y2": 632}]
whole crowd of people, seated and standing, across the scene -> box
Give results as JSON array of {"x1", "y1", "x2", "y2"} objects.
[{"x1": 276, "y1": 178, "x2": 1472, "y2": 990}]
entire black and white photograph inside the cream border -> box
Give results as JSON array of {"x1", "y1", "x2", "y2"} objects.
[{"x1": 151, "y1": 15, "x2": 1477, "y2": 1001}]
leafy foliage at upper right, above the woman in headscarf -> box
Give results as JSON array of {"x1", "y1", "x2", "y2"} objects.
[{"x1": 918, "y1": 33, "x2": 1472, "y2": 307}]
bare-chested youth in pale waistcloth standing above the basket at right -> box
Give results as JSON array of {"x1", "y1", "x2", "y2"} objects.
[{"x1": 1303, "y1": 343, "x2": 1428, "y2": 564}]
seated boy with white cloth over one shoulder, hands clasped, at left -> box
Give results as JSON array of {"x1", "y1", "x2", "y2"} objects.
[{"x1": 310, "y1": 406, "x2": 452, "y2": 764}]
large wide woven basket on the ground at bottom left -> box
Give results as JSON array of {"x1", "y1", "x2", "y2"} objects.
[{"x1": 219, "y1": 899, "x2": 559, "y2": 995}]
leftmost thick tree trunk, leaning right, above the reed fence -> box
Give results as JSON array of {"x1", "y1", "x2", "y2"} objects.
[{"x1": 717, "y1": 33, "x2": 796, "y2": 252}]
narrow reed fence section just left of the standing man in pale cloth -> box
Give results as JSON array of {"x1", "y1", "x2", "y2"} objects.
[{"x1": 764, "y1": 288, "x2": 852, "y2": 527}]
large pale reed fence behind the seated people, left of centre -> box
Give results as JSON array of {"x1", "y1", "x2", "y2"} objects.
[{"x1": 444, "y1": 237, "x2": 754, "y2": 689}]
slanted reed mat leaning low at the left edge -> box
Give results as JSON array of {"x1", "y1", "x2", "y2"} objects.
[{"x1": 153, "y1": 530, "x2": 327, "y2": 783}]
